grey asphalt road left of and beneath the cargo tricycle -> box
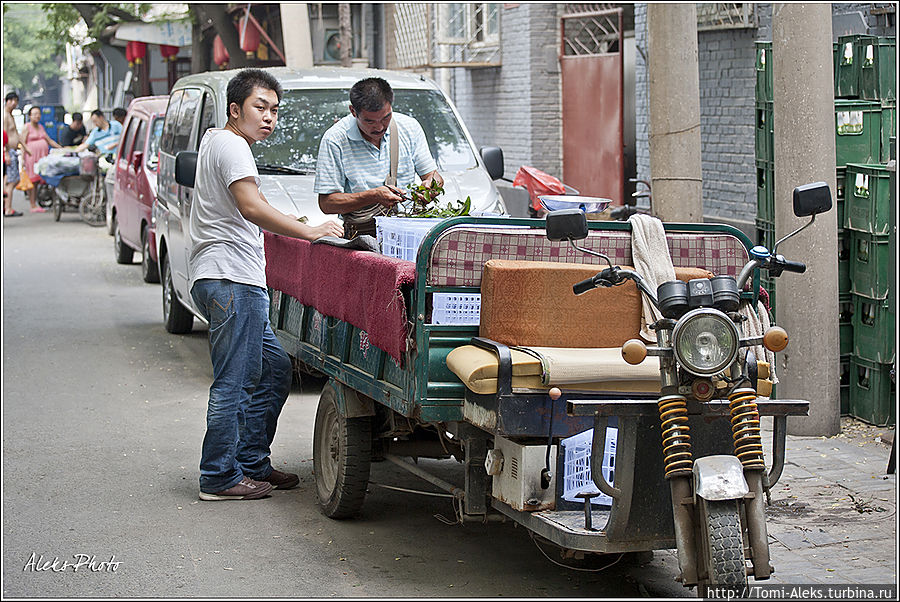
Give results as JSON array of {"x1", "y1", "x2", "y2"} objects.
[{"x1": 2, "y1": 199, "x2": 690, "y2": 597}]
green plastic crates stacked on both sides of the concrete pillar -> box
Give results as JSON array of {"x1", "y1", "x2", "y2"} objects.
[{"x1": 755, "y1": 35, "x2": 897, "y2": 425}]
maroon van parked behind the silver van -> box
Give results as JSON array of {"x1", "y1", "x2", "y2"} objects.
[{"x1": 109, "y1": 96, "x2": 169, "y2": 282}]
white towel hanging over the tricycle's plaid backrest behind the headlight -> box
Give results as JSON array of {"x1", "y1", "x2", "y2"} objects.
[{"x1": 628, "y1": 213, "x2": 675, "y2": 343}]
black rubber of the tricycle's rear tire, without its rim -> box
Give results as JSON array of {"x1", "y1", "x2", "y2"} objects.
[{"x1": 313, "y1": 383, "x2": 372, "y2": 519}]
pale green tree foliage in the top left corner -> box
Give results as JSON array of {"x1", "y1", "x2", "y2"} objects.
[{"x1": 3, "y1": 4, "x2": 60, "y2": 94}]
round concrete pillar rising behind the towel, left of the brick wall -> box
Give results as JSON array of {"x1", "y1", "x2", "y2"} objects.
[{"x1": 647, "y1": 3, "x2": 703, "y2": 222}]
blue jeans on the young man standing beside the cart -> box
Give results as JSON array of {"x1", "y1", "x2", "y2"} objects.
[{"x1": 191, "y1": 279, "x2": 291, "y2": 493}]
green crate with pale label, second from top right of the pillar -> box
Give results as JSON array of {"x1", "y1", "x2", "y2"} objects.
[{"x1": 834, "y1": 100, "x2": 882, "y2": 167}]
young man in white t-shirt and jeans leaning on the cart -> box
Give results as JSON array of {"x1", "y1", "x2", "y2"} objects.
[{"x1": 188, "y1": 69, "x2": 343, "y2": 501}]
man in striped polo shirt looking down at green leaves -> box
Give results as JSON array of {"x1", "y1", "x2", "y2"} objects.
[{"x1": 315, "y1": 77, "x2": 444, "y2": 238}]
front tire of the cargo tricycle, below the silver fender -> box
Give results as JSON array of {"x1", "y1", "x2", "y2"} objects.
[{"x1": 698, "y1": 500, "x2": 747, "y2": 596}]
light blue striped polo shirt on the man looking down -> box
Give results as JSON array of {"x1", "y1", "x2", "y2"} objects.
[{"x1": 314, "y1": 113, "x2": 437, "y2": 194}]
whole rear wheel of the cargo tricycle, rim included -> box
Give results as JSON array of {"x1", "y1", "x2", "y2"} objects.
[{"x1": 313, "y1": 381, "x2": 372, "y2": 519}]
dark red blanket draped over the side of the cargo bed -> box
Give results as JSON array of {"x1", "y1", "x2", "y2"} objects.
[{"x1": 265, "y1": 232, "x2": 416, "y2": 361}]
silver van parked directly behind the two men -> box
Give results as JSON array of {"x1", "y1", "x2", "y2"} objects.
[{"x1": 154, "y1": 67, "x2": 506, "y2": 333}]
